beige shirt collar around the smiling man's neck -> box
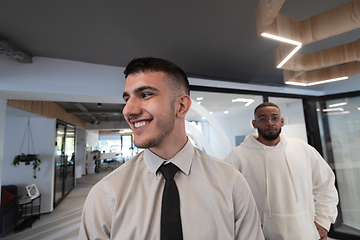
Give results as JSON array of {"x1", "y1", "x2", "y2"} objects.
[{"x1": 144, "y1": 139, "x2": 194, "y2": 175}]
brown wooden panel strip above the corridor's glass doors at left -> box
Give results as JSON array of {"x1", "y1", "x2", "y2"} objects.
[{"x1": 7, "y1": 100, "x2": 86, "y2": 130}]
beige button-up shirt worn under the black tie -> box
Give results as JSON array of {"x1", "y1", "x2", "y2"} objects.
[{"x1": 79, "y1": 141, "x2": 264, "y2": 240}]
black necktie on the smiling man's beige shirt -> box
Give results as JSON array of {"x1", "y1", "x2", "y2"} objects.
[{"x1": 159, "y1": 163, "x2": 183, "y2": 240}]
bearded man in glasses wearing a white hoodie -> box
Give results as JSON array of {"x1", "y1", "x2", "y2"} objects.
[{"x1": 225, "y1": 102, "x2": 338, "y2": 240}]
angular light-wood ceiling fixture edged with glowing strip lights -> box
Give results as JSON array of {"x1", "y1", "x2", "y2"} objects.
[{"x1": 257, "y1": 0, "x2": 360, "y2": 83}]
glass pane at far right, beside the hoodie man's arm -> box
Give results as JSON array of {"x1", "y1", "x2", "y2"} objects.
[{"x1": 316, "y1": 97, "x2": 360, "y2": 236}]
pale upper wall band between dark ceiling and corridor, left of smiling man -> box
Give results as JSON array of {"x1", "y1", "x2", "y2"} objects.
[{"x1": 0, "y1": 56, "x2": 125, "y2": 103}]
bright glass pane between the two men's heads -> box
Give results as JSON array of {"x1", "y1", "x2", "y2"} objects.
[{"x1": 186, "y1": 91, "x2": 262, "y2": 159}]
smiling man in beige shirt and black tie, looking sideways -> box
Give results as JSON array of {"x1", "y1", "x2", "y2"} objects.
[{"x1": 80, "y1": 58, "x2": 264, "y2": 240}]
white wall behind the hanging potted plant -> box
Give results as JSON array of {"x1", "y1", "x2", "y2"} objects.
[{"x1": 1, "y1": 107, "x2": 56, "y2": 212}]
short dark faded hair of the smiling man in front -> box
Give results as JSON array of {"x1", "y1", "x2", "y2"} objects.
[{"x1": 124, "y1": 57, "x2": 190, "y2": 96}]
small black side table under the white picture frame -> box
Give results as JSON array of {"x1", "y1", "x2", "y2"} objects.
[{"x1": 15, "y1": 194, "x2": 41, "y2": 231}]
